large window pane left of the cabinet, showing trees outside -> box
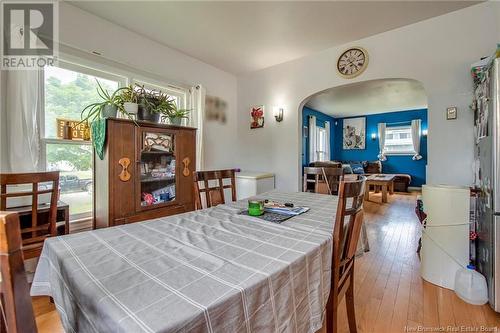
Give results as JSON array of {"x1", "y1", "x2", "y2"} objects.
[{"x1": 42, "y1": 62, "x2": 126, "y2": 220}]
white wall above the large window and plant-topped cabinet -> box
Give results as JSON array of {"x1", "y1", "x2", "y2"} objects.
[{"x1": 59, "y1": 2, "x2": 236, "y2": 169}]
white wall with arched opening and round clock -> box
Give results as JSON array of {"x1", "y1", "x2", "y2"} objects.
[{"x1": 237, "y1": 3, "x2": 500, "y2": 191}]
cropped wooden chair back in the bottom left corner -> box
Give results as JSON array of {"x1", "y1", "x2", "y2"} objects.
[{"x1": 0, "y1": 211, "x2": 37, "y2": 333}]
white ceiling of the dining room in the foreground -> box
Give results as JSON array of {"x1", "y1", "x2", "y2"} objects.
[{"x1": 71, "y1": 1, "x2": 478, "y2": 74}]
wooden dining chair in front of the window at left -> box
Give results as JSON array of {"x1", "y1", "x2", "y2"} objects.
[{"x1": 0, "y1": 171, "x2": 59, "y2": 259}]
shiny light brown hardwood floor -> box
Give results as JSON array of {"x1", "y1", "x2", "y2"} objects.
[{"x1": 33, "y1": 193, "x2": 500, "y2": 333}]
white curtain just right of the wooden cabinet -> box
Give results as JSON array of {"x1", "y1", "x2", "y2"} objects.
[{"x1": 187, "y1": 85, "x2": 206, "y2": 170}]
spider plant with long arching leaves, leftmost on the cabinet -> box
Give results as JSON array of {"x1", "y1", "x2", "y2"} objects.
[{"x1": 81, "y1": 79, "x2": 128, "y2": 123}]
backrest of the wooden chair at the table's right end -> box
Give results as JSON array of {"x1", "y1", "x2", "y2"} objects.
[{"x1": 332, "y1": 176, "x2": 366, "y2": 293}]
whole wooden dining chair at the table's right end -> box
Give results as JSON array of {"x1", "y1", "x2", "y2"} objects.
[{"x1": 326, "y1": 176, "x2": 365, "y2": 333}]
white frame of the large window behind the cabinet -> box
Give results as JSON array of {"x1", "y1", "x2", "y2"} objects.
[{"x1": 39, "y1": 52, "x2": 189, "y2": 222}]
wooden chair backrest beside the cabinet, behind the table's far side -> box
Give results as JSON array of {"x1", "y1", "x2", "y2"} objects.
[{"x1": 193, "y1": 169, "x2": 236, "y2": 209}]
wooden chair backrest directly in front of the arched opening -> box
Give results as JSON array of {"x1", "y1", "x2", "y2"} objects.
[{"x1": 303, "y1": 167, "x2": 344, "y2": 194}]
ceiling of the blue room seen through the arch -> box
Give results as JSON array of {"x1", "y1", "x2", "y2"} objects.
[{"x1": 305, "y1": 79, "x2": 427, "y2": 118}]
